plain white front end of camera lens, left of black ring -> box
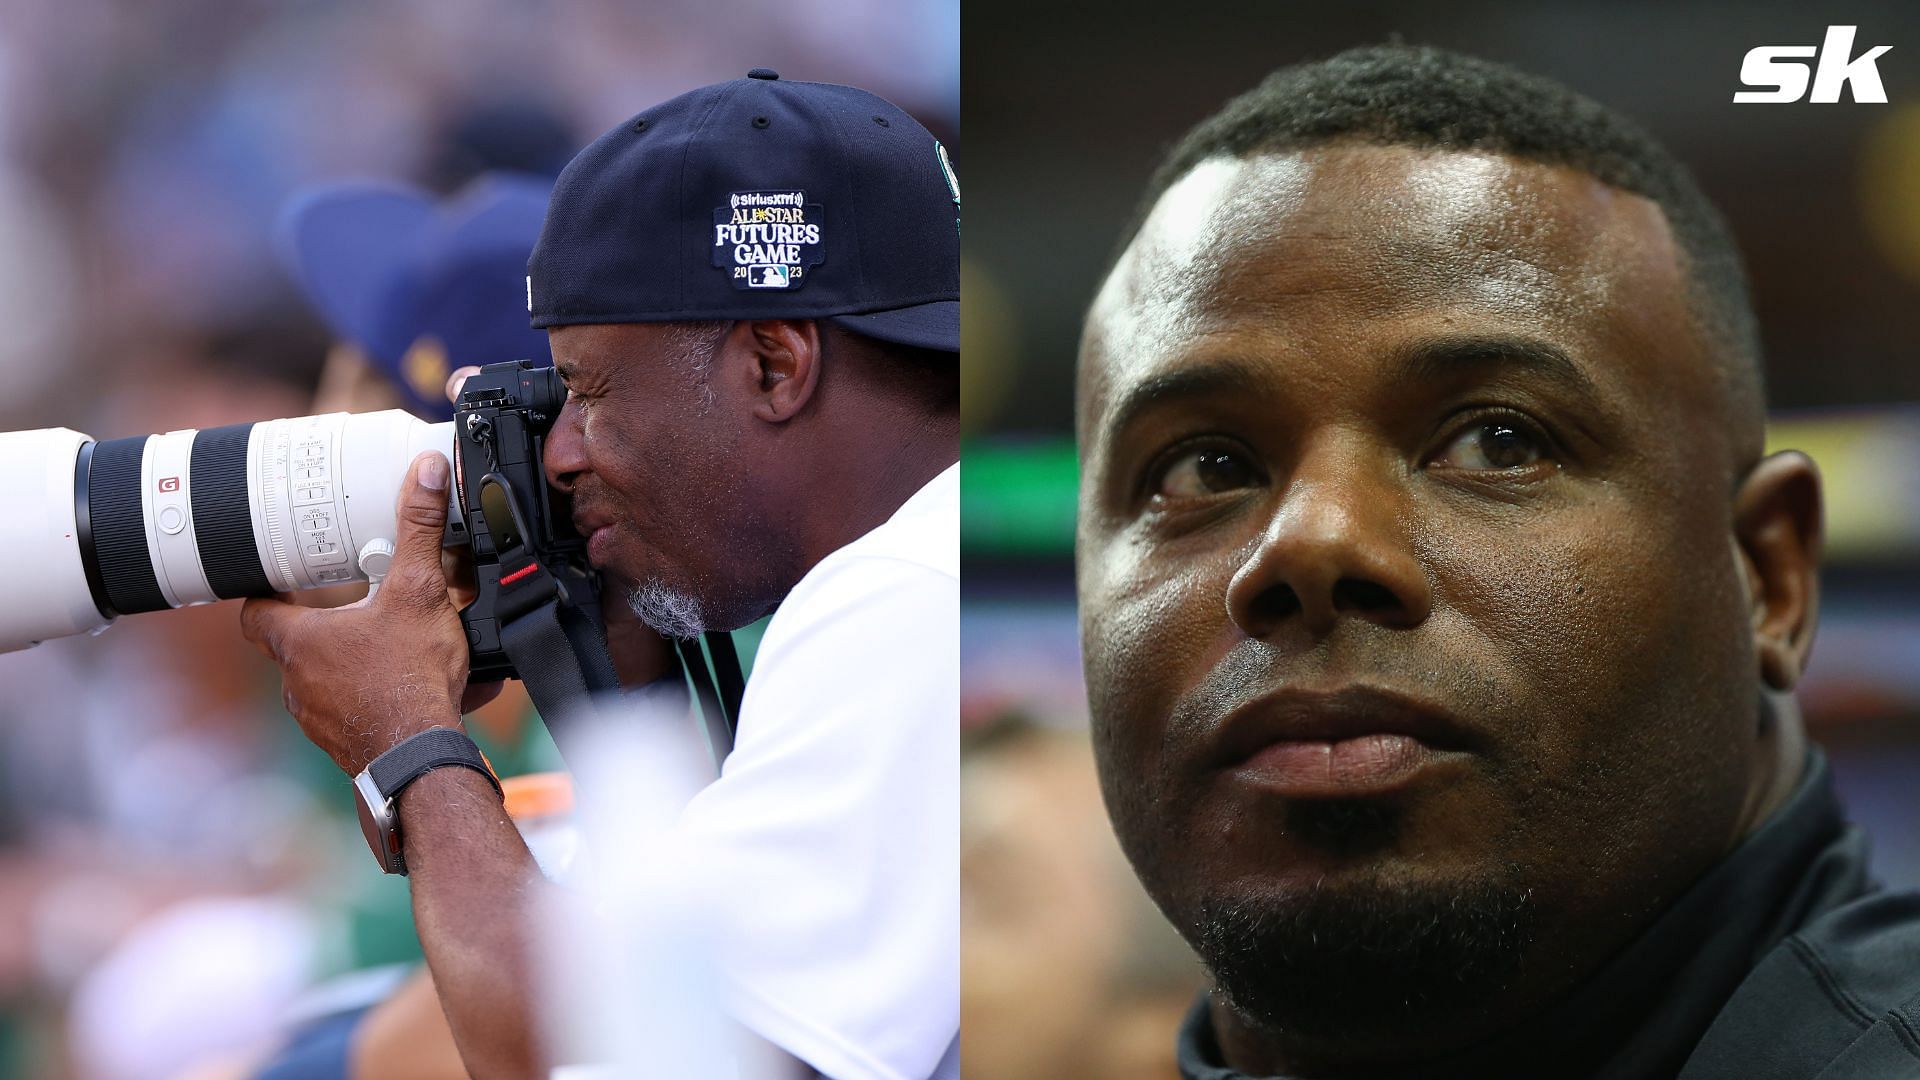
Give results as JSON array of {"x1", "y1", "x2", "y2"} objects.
[{"x1": 0, "y1": 427, "x2": 108, "y2": 651}]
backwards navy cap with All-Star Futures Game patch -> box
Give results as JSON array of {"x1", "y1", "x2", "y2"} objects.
[{"x1": 526, "y1": 67, "x2": 960, "y2": 352}]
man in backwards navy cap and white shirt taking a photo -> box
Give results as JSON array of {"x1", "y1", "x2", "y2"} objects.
[{"x1": 242, "y1": 69, "x2": 960, "y2": 1078}]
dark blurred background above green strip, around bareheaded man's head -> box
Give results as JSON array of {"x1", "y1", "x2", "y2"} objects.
[{"x1": 964, "y1": 0, "x2": 1920, "y2": 432}]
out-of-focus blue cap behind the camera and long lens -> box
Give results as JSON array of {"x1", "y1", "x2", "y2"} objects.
[{"x1": 276, "y1": 173, "x2": 553, "y2": 419}]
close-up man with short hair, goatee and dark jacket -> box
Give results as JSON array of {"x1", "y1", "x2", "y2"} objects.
[{"x1": 1077, "y1": 46, "x2": 1920, "y2": 1080}]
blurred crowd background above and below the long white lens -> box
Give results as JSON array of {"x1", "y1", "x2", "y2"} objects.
[{"x1": 0, "y1": 0, "x2": 966, "y2": 1080}]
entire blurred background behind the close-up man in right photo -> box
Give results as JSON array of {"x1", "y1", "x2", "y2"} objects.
[{"x1": 962, "y1": 0, "x2": 1920, "y2": 1080}]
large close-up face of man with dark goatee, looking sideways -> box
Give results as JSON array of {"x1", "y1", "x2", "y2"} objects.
[{"x1": 1077, "y1": 144, "x2": 1781, "y2": 1053}]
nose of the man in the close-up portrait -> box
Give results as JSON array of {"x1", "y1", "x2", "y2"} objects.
[{"x1": 1227, "y1": 434, "x2": 1432, "y2": 638}]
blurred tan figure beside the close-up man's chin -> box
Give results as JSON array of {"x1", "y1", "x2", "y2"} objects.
[{"x1": 960, "y1": 717, "x2": 1202, "y2": 1080}]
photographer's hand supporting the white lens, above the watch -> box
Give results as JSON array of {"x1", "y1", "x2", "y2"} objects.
[{"x1": 240, "y1": 454, "x2": 472, "y2": 774}]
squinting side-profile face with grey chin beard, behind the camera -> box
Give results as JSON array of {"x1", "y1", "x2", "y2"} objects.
[{"x1": 545, "y1": 323, "x2": 780, "y2": 636}]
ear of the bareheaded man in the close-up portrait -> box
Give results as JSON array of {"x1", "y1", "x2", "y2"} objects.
[{"x1": 1734, "y1": 450, "x2": 1820, "y2": 690}]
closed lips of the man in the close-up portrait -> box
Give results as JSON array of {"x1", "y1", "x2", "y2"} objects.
[{"x1": 1208, "y1": 686, "x2": 1476, "y2": 799}]
